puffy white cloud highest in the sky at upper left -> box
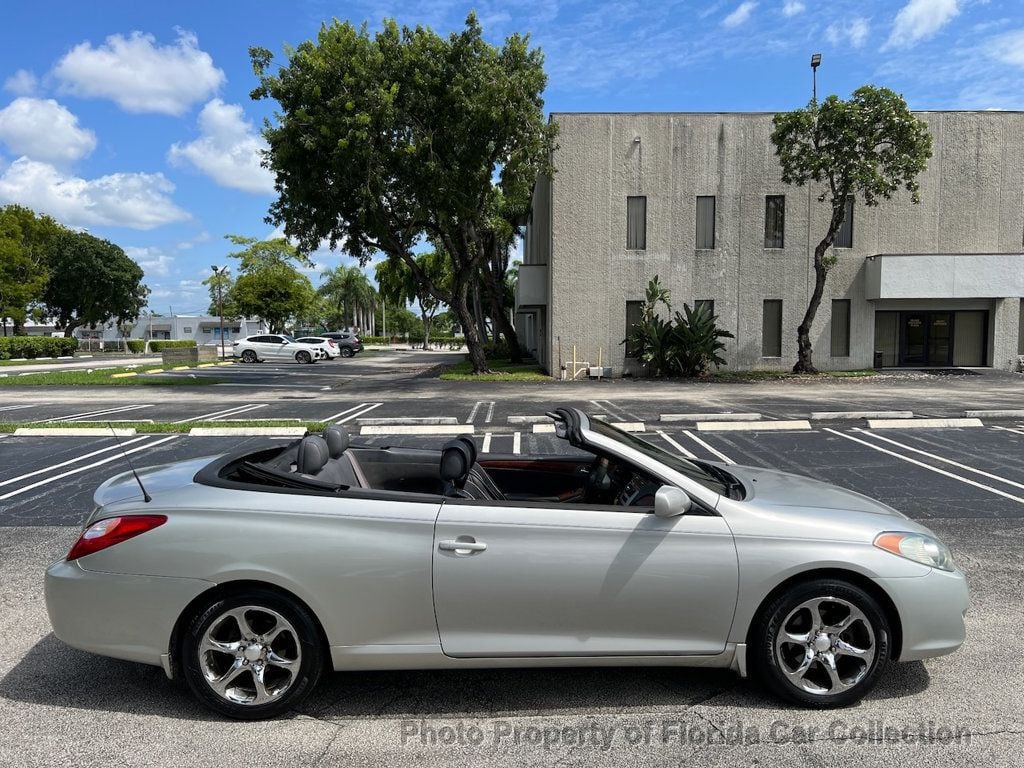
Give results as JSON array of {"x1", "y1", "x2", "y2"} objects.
[{"x1": 53, "y1": 30, "x2": 225, "y2": 115}]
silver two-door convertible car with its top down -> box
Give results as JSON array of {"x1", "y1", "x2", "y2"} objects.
[{"x1": 46, "y1": 408, "x2": 969, "y2": 719}]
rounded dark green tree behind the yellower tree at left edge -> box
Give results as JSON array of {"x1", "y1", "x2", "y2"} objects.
[{"x1": 42, "y1": 230, "x2": 150, "y2": 337}]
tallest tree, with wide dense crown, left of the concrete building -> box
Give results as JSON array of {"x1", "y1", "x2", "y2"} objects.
[{"x1": 250, "y1": 13, "x2": 555, "y2": 372}]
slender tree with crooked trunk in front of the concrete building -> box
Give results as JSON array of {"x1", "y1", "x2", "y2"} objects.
[{"x1": 771, "y1": 85, "x2": 932, "y2": 373}]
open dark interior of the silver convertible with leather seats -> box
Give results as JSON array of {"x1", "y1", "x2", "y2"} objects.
[{"x1": 204, "y1": 425, "x2": 662, "y2": 507}]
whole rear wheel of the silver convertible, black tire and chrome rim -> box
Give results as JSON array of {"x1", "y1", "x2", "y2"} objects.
[{"x1": 180, "y1": 589, "x2": 326, "y2": 720}]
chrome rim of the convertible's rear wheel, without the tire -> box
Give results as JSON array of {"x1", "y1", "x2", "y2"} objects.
[{"x1": 199, "y1": 605, "x2": 302, "y2": 706}]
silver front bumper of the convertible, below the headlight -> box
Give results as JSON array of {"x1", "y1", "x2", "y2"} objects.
[{"x1": 874, "y1": 568, "x2": 971, "y2": 662}]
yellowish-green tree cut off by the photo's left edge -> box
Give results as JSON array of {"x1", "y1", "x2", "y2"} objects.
[{"x1": 0, "y1": 205, "x2": 63, "y2": 336}]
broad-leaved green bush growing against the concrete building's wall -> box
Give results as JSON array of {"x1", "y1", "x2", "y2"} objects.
[{"x1": 622, "y1": 274, "x2": 734, "y2": 376}]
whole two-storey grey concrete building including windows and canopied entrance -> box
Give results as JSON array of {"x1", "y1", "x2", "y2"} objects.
[{"x1": 516, "y1": 112, "x2": 1024, "y2": 375}]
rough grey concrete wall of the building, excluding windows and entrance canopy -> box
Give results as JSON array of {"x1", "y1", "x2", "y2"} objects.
[{"x1": 524, "y1": 112, "x2": 1024, "y2": 374}]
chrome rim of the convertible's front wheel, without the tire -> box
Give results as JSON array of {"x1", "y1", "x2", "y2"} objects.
[{"x1": 775, "y1": 597, "x2": 877, "y2": 696}]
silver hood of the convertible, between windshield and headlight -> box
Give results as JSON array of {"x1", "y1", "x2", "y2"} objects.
[{"x1": 722, "y1": 465, "x2": 907, "y2": 520}]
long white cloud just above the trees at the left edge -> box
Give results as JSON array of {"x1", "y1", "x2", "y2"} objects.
[{"x1": 0, "y1": 158, "x2": 189, "y2": 229}]
